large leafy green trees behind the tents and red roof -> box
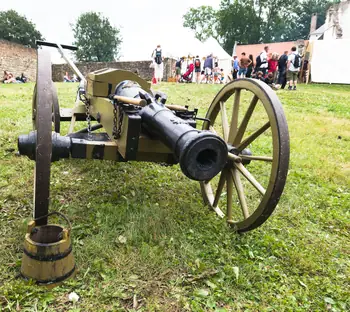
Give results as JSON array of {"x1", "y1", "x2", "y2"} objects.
[{"x1": 183, "y1": 0, "x2": 339, "y2": 53}]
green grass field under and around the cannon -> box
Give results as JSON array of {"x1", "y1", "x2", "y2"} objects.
[{"x1": 0, "y1": 83, "x2": 350, "y2": 312}]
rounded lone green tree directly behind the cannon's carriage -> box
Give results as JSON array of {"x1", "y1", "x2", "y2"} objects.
[{"x1": 72, "y1": 12, "x2": 122, "y2": 62}]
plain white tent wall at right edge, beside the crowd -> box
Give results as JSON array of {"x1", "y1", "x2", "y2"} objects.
[{"x1": 311, "y1": 39, "x2": 350, "y2": 84}]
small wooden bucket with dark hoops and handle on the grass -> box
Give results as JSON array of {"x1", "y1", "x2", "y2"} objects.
[{"x1": 21, "y1": 212, "x2": 75, "y2": 286}]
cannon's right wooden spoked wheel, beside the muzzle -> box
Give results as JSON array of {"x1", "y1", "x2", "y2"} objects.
[{"x1": 200, "y1": 79, "x2": 289, "y2": 232}]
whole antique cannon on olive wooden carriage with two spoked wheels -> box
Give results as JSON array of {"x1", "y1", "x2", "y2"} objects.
[{"x1": 18, "y1": 42, "x2": 289, "y2": 232}]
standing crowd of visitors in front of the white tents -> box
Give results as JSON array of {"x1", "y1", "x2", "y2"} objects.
[{"x1": 151, "y1": 45, "x2": 301, "y2": 90}]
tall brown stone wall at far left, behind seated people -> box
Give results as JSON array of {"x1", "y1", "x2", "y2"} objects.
[{"x1": 0, "y1": 40, "x2": 36, "y2": 81}]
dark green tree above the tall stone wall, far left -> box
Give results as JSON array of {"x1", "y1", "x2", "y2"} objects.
[{"x1": 0, "y1": 10, "x2": 44, "y2": 48}]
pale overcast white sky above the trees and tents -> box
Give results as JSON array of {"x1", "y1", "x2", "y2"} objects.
[{"x1": 0, "y1": 0, "x2": 221, "y2": 63}]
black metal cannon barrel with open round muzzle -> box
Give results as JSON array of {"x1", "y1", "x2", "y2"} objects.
[{"x1": 115, "y1": 81, "x2": 228, "y2": 181}]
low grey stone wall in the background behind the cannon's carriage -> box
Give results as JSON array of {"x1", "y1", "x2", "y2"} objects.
[{"x1": 52, "y1": 59, "x2": 175, "y2": 81}]
